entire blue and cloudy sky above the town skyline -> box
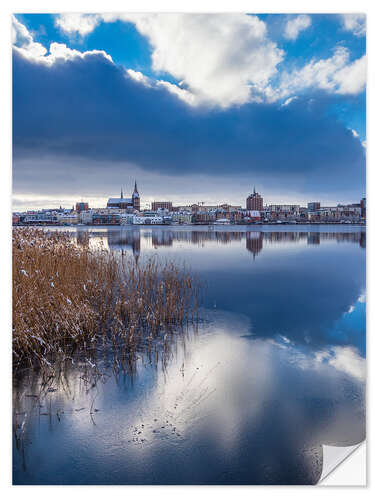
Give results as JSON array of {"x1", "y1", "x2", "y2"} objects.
[{"x1": 12, "y1": 13, "x2": 366, "y2": 210}]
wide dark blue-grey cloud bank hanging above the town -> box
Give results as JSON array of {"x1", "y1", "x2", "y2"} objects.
[{"x1": 13, "y1": 47, "x2": 365, "y2": 201}]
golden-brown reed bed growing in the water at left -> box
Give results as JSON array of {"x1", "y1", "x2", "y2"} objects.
[{"x1": 13, "y1": 228, "x2": 198, "y2": 369}]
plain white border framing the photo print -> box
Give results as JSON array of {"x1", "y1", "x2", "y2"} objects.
[{"x1": 0, "y1": 0, "x2": 375, "y2": 500}]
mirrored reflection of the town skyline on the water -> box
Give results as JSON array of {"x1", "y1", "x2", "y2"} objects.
[{"x1": 101, "y1": 228, "x2": 366, "y2": 260}]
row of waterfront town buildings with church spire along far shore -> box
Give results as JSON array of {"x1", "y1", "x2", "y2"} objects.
[{"x1": 13, "y1": 181, "x2": 366, "y2": 225}]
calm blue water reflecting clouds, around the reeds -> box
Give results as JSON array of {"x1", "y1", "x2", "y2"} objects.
[{"x1": 13, "y1": 226, "x2": 366, "y2": 484}]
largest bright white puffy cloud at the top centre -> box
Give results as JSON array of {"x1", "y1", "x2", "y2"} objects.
[{"x1": 56, "y1": 13, "x2": 284, "y2": 107}]
